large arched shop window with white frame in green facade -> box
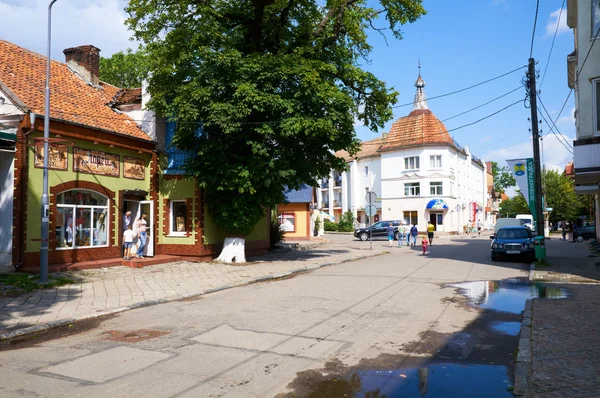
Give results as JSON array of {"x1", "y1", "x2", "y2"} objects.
[{"x1": 55, "y1": 190, "x2": 110, "y2": 249}]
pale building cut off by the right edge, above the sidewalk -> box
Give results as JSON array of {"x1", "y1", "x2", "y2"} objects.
[{"x1": 567, "y1": 0, "x2": 600, "y2": 236}]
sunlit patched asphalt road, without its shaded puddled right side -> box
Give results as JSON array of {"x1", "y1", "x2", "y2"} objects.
[{"x1": 0, "y1": 236, "x2": 526, "y2": 397}]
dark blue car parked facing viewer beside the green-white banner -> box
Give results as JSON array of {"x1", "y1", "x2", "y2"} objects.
[{"x1": 490, "y1": 227, "x2": 535, "y2": 261}]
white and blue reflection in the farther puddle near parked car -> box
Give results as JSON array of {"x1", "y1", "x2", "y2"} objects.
[{"x1": 448, "y1": 279, "x2": 567, "y2": 314}]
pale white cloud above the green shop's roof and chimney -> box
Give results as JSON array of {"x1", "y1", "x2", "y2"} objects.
[{"x1": 0, "y1": 0, "x2": 137, "y2": 62}]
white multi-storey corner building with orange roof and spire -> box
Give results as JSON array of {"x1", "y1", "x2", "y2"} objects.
[{"x1": 317, "y1": 75, "x2": 487, "y2": 232}]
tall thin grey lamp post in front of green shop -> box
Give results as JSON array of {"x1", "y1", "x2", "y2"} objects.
[{"x1": 40, "y1": 0, "x2": 56, "y2": 283}]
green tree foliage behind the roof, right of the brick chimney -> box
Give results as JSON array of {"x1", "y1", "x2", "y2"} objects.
[{"x1": 99, "y1": 46, "x2": 150, "y2": 88}]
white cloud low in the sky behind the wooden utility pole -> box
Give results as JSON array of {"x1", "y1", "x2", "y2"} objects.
[{"x1": 484, "y1": 133, "x2": 573, "y2": 177}]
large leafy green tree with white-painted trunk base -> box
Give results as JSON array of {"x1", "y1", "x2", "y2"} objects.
[{"x1": 126, "y1": 0, "x2": 425, "y2": 261}]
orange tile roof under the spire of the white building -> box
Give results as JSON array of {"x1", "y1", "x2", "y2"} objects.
[{"x1": 381, "y1": 109, "x2": 454, "y2": 151}]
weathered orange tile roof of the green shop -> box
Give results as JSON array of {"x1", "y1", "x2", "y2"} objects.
[{"x1": 0, "y1": 40, "x2": 152, "y2": 141}]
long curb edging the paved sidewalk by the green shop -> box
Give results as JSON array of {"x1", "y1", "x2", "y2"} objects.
[{"x1": 0, "y1": 252, "x2": 387, "y2": 342}]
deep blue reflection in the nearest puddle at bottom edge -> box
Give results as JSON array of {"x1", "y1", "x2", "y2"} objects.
[{"x1": 355, "y1": 363, "x2": 512, "y2": 397}]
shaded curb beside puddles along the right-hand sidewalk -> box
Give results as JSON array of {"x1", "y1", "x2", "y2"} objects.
[{"x1": 513, "y1": 299, "x2": 533, "y2": 396}]
